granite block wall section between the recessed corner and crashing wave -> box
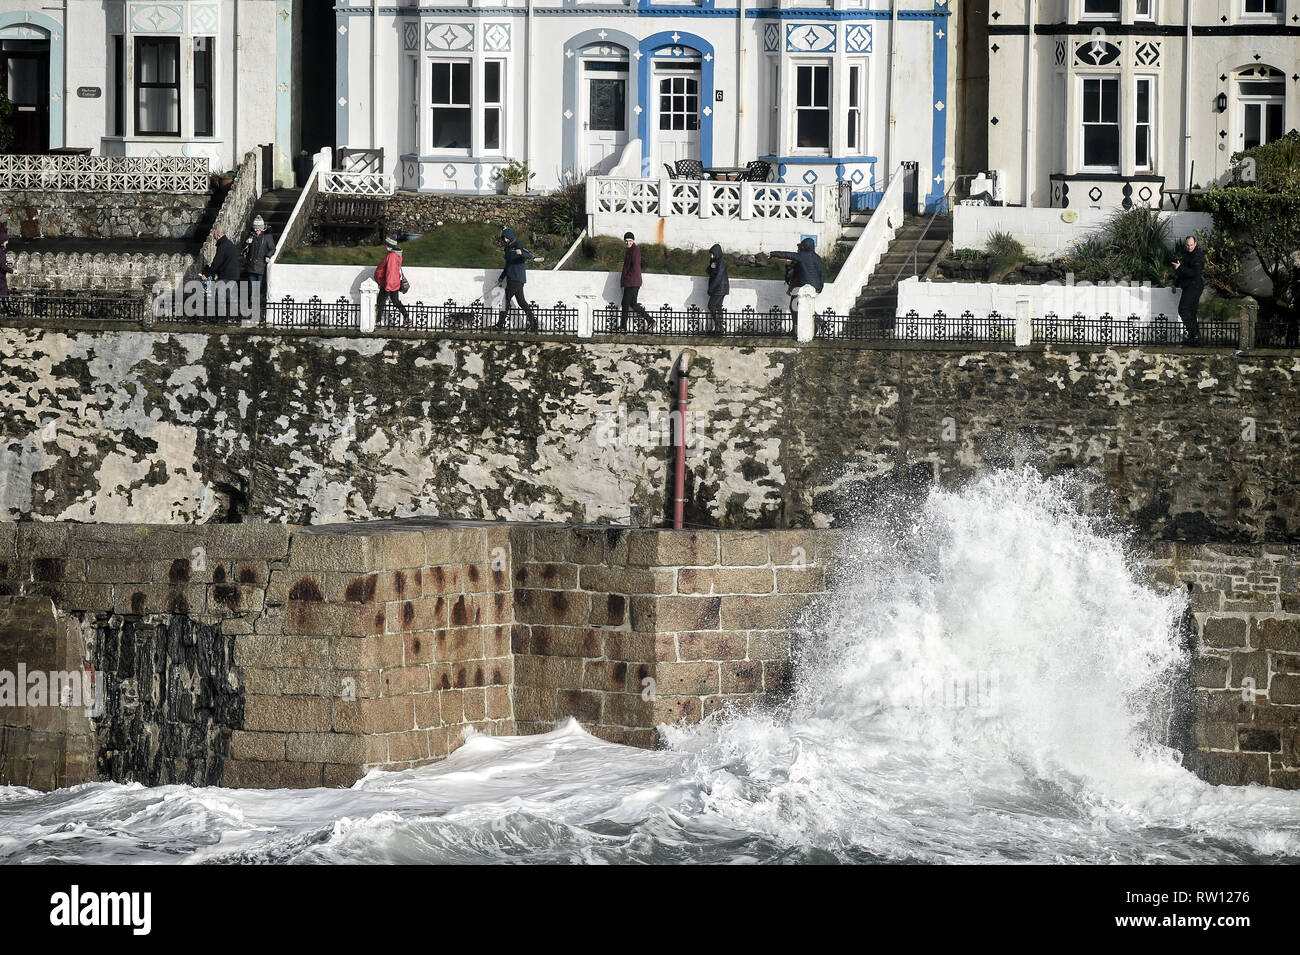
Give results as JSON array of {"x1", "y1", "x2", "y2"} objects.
[{"x1": 501, "y1": 528, "x2": 839, "y2": 746}]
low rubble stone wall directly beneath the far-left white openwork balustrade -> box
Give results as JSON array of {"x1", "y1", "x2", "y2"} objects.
[{"x1": 0, "y1": 190, "x2": 212, "y2": 239}]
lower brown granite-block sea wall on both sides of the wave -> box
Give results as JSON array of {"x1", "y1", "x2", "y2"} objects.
[{"x1": 0, "y1": 521, "x2": 1300, "y2": 789}]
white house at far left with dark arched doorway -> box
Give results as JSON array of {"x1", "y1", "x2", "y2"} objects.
[{"x1": 0, "y1": 0, "x2": 308, "y2": 181}]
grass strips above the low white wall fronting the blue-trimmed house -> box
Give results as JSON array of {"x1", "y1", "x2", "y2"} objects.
[{"x1": 281, "y1": 222, "x2": 844, "y2": 282}]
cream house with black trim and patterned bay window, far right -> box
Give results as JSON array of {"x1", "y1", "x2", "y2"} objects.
[{"x1": 982, "y1": 0, "x2": 1300, "y2": 209}]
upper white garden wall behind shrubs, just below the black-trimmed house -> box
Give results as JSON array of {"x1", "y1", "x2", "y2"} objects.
[{"x1": 953, "y1": 205, "x2": 1214, "y2": 259}]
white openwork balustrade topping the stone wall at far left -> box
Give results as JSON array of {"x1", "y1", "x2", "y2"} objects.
[{"x1": 0, "y1": 156, "x2": 212, "y2": 194}]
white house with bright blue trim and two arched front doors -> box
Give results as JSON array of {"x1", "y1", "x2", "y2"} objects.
[{"x1": 335, "y1": 0, "x2": 956, "y2": 205}]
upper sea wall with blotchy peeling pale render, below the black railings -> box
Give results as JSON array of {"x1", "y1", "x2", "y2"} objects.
[{"x1": 0, "y1": 327, "x2": 1300, "y2": 542}]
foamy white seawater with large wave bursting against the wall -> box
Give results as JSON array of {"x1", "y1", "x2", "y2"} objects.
[{"x1": 0, "y1": 473, "x2": 1300, "y2": 863}]
